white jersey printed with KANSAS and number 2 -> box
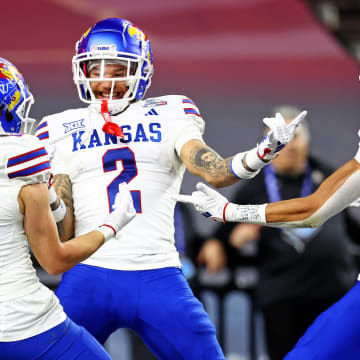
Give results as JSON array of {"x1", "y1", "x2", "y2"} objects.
[{"x1": 36, "y1": 95, "x2": 205, "y2": 270}]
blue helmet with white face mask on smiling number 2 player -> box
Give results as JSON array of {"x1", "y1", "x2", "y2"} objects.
[{"x1": 72, "y1": 18, "x2": 153, "y2": 114}]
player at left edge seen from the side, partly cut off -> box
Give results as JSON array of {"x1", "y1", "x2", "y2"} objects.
[{"x1": 0, "y1": 58, "x2": 136, "y2": 360}]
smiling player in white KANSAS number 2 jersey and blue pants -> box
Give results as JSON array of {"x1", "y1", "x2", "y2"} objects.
[{"x1": 36, "y1": 18, "x2": 306, "y2": 360}]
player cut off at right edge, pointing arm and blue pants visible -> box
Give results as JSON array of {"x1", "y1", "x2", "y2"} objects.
[{"x1": 174, "y1": 131, "x2": 360, "y2": 360}]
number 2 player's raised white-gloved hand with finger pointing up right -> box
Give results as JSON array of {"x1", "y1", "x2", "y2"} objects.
[{"x1": 257, "y1": 111, "x2": 307, "y2": 161}]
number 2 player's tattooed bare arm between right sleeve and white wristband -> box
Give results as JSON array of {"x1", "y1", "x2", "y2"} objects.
[{"x1": 181, "y1": 140, "x2": 239, "y2": 187}]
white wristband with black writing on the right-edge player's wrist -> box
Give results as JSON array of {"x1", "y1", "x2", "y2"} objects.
[{"x1": 224, "y1": 203, "x2": 267, "y2": 225}]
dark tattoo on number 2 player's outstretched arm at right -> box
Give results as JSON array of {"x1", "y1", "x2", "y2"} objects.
[{"x1": 190, "y1": 145, "x2": 232, "y2": 177}]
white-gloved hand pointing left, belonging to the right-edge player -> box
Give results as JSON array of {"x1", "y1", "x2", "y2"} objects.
[{"x1": 174, "y1": 183, "x2": 229, "y2": 222}]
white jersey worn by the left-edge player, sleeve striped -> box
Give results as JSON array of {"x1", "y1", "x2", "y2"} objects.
[{"x1": 0, "y1": 134, "x2": 66, "y2": 342}]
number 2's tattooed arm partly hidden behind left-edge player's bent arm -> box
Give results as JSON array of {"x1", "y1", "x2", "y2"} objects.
[{"x1": 53, "y1": 174, "x2": 74, "y2": 241}]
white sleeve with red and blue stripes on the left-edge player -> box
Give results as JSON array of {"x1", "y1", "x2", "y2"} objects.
[{"x1": 6, "y1": 134, "x2": 51, "y2": 185}]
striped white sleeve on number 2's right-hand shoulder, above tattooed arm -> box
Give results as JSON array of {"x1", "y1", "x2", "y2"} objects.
[{"x1": 175, "y1": 97, "x2": 205, "y2": 155}]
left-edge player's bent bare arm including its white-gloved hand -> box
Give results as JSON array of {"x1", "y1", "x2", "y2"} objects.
[{"x1": 18, "y1": 183, "x2": 136, "y2": 275}]
